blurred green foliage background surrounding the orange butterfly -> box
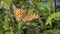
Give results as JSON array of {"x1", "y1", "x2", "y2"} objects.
[{"x1": 0, "y1": 0, "x2": 60, "y2": 34}]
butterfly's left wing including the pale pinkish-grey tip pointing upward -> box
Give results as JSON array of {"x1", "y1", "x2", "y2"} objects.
[{"x1": 12, "y1": 4, "x2": 26, "y2": 21}]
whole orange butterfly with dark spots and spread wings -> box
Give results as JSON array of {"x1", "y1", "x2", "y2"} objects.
[{"x1": 13, "y1": 5, "x2": 39, "y2": 22}]
